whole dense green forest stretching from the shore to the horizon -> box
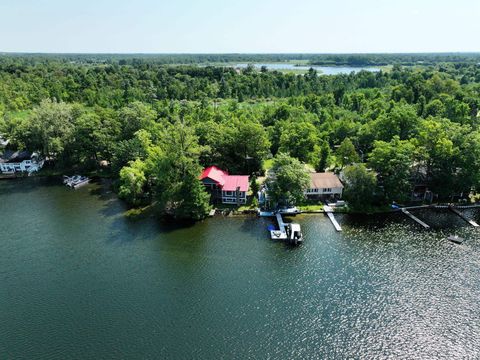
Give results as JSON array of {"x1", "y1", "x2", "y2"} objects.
[{"x1": 0, "y1": 56, "x2": 480, "y2": 219}]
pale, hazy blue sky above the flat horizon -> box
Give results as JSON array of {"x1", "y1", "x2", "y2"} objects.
[{"x1": 0, "y1": 0, "x2": 480, "y2": 53}]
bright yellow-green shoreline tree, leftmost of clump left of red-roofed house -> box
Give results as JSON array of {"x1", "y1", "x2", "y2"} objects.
[{"x1": 118, "y1": 159, "x2": 147, "y2": 206}]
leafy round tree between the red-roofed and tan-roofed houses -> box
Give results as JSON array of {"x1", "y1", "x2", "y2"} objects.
[{"x1": 266, "y1": 153, "x2": 310, "y2": 205}]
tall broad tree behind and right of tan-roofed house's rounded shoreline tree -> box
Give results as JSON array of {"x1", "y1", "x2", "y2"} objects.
[{"x1": 369, "y1": 136, "x2": 415, "y2": 202}]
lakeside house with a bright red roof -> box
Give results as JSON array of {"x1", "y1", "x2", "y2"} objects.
[{"x1": 200, "y1": 166, "x2": 249, "y2": 205}]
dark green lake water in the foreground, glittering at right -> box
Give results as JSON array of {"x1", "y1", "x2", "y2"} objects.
[{"x1": 0, "y1": 179, "x2": 480, "y2": 359}]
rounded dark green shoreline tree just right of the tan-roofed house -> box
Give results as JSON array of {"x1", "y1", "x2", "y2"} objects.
[{"x1": 343, "y1": 164, "x2": 377, "y2": 211}]
